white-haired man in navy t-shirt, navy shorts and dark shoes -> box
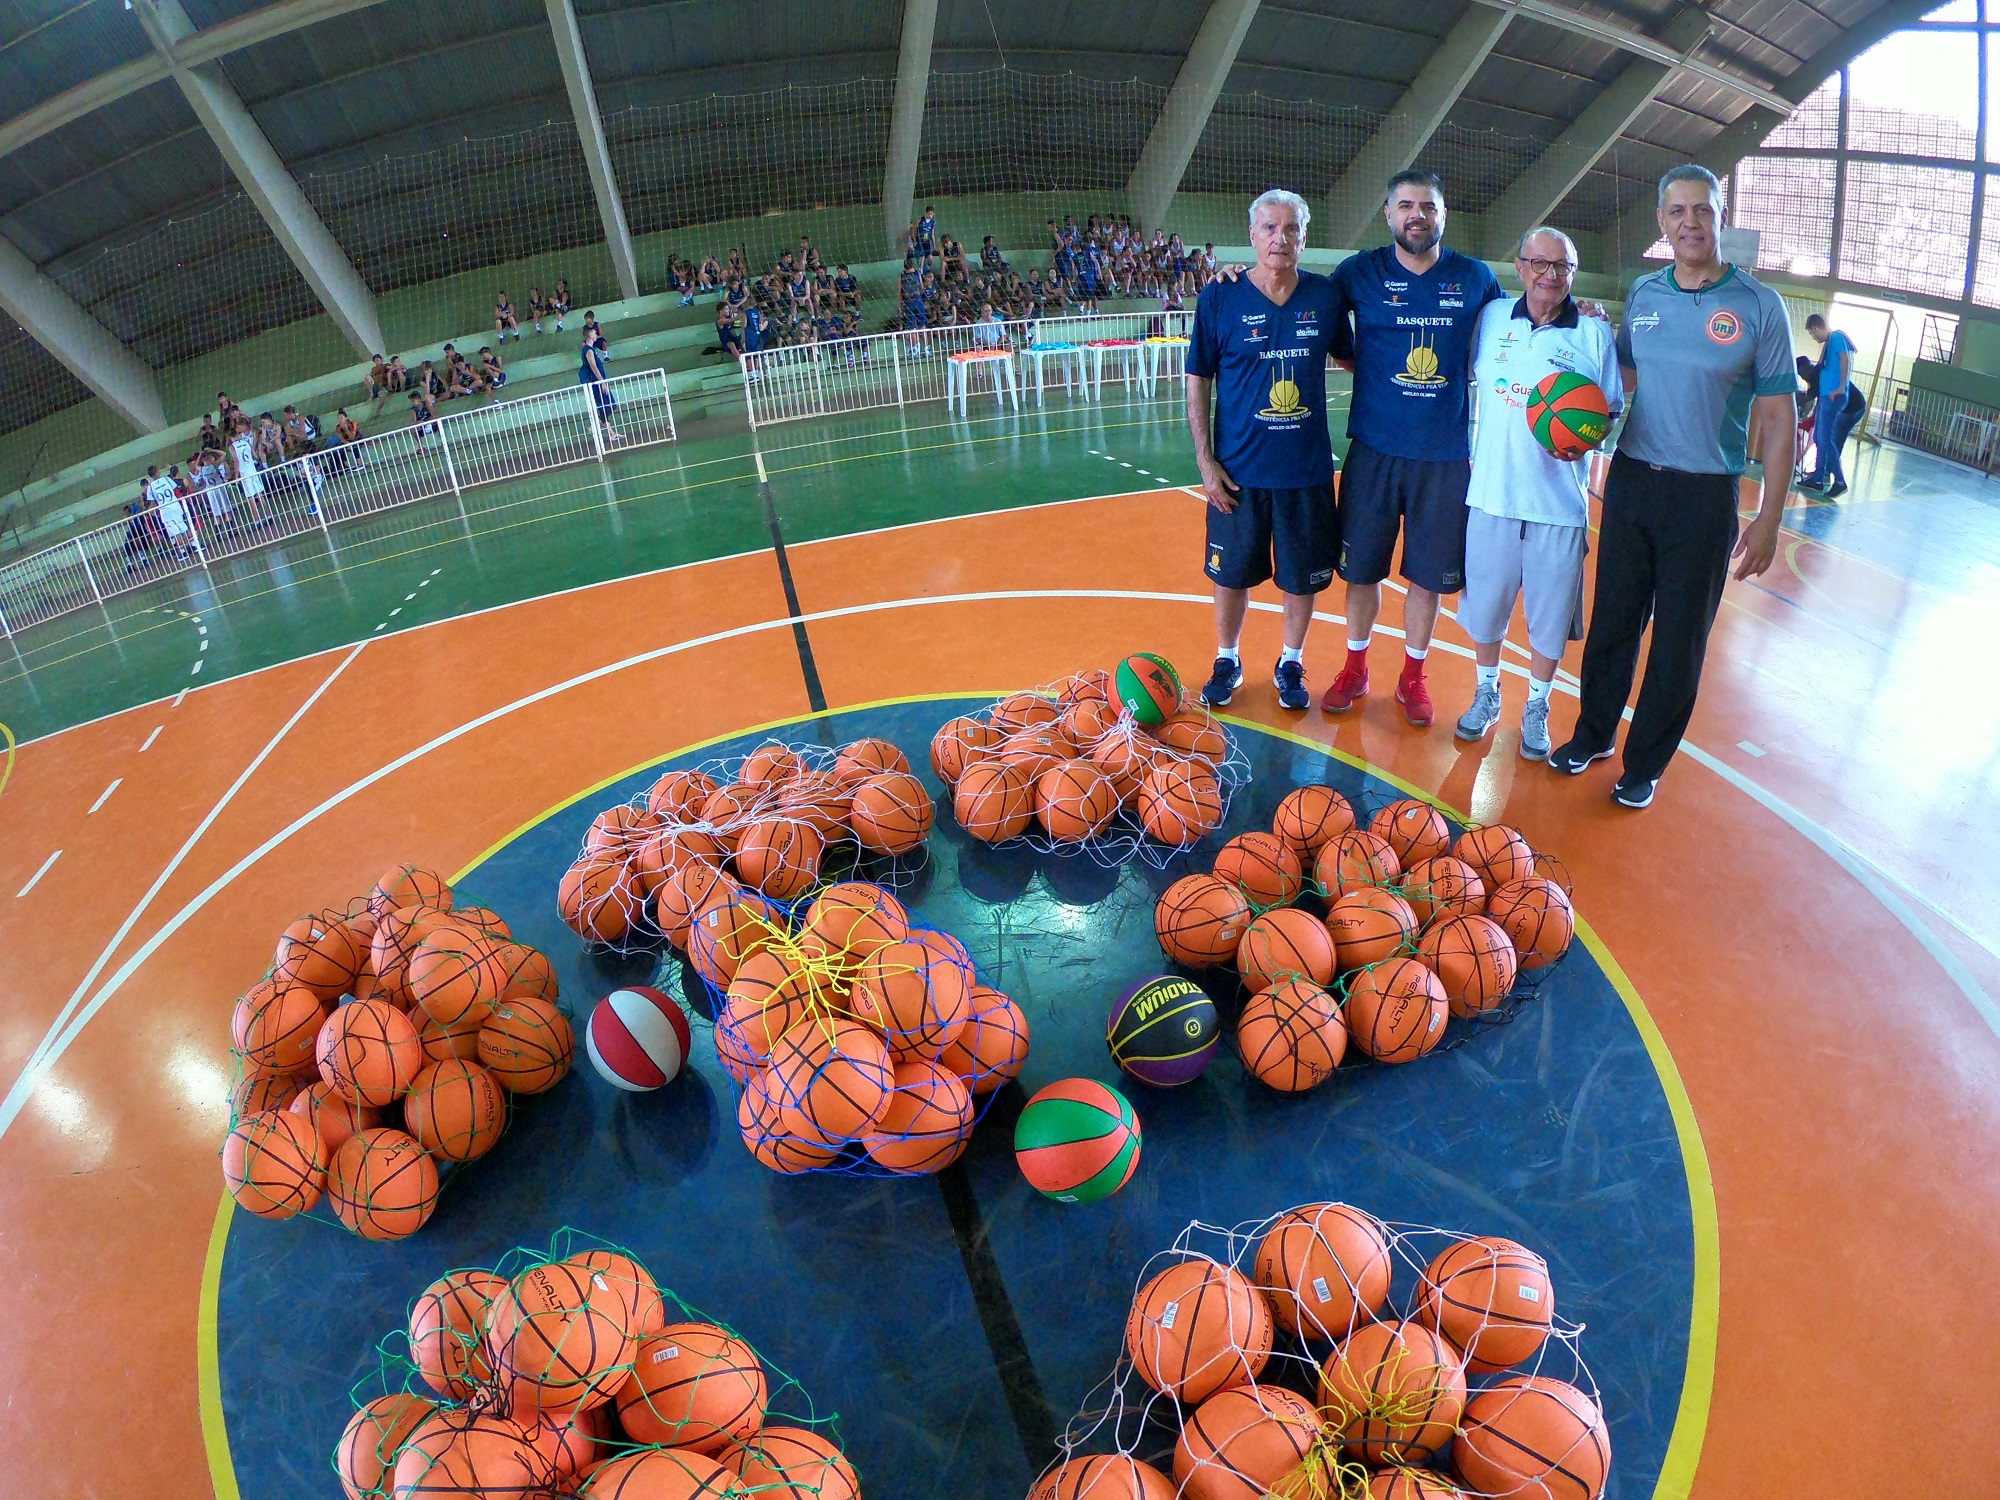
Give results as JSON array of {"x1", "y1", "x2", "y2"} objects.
[{"x1": 1188, "y1": 188, "x2": 1340, "y2": 712}]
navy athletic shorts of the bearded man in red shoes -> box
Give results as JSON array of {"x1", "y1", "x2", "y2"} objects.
[{"x1": 1340, "y1": 442, "x2": 1472, "y2": 594}]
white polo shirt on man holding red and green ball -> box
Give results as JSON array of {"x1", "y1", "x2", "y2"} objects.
[{"x1": 1466, "y1": 298, "x2": 1624, "y2": 526}]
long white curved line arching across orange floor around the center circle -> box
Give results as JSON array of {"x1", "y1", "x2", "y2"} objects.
[{"x1": 0, "y1": 588, "x2": 2000, "y2": 1136}]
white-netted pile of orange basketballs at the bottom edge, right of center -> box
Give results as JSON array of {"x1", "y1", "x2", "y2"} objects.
[{"x1": 1030, "y1": 1202, "x2": 1610, "y2": 1500}]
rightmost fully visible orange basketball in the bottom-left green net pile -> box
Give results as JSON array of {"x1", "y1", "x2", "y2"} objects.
[{"x1": 618, "y1": 1322, "x2": 770, "y2": 1456}]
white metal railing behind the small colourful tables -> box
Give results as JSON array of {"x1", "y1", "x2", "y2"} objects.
[{"x1": 742, "y1": 312, "x2": 1194, "y2": 428}]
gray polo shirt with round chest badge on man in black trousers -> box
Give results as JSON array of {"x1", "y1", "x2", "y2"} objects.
[{"x1": 1618, "y1": 266, "x2": 1798, "y2": 474}]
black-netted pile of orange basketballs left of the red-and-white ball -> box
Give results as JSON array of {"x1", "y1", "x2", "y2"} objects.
[{"x1": 222, "y1": 866, "x2": 576, "y2": 1240}]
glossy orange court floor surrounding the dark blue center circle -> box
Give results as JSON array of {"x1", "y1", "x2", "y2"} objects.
[{"x1": 0, "y1": 428, "x2": 2000, "y2": 1500}]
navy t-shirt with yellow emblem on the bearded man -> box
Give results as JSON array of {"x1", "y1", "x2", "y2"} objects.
[{"x1": 1332, "y1": 246, "x2": 1504, "y2": 460}]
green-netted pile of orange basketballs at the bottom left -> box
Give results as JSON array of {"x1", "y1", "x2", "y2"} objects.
[{"x1": 332, "y1": 1226, "x2": 860, "y2": 1500}]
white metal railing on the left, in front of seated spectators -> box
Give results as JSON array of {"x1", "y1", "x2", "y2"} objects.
[{"x1": 0, "y1": 370, "x2": 678, "y2": 636}]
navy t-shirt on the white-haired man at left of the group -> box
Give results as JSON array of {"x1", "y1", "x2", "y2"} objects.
[{"x1": 1188, "y1": 270, "x2": 1336, "y2": 490}]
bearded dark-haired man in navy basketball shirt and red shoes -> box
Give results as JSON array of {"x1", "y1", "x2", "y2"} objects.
[{"x1": 1320, "y1": 170, "x2": 1502, "y2": 726}]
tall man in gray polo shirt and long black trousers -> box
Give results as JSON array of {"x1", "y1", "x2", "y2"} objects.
[{"x1": 1548, "y1": 166, "x2": 1798, "y2": 808}]
